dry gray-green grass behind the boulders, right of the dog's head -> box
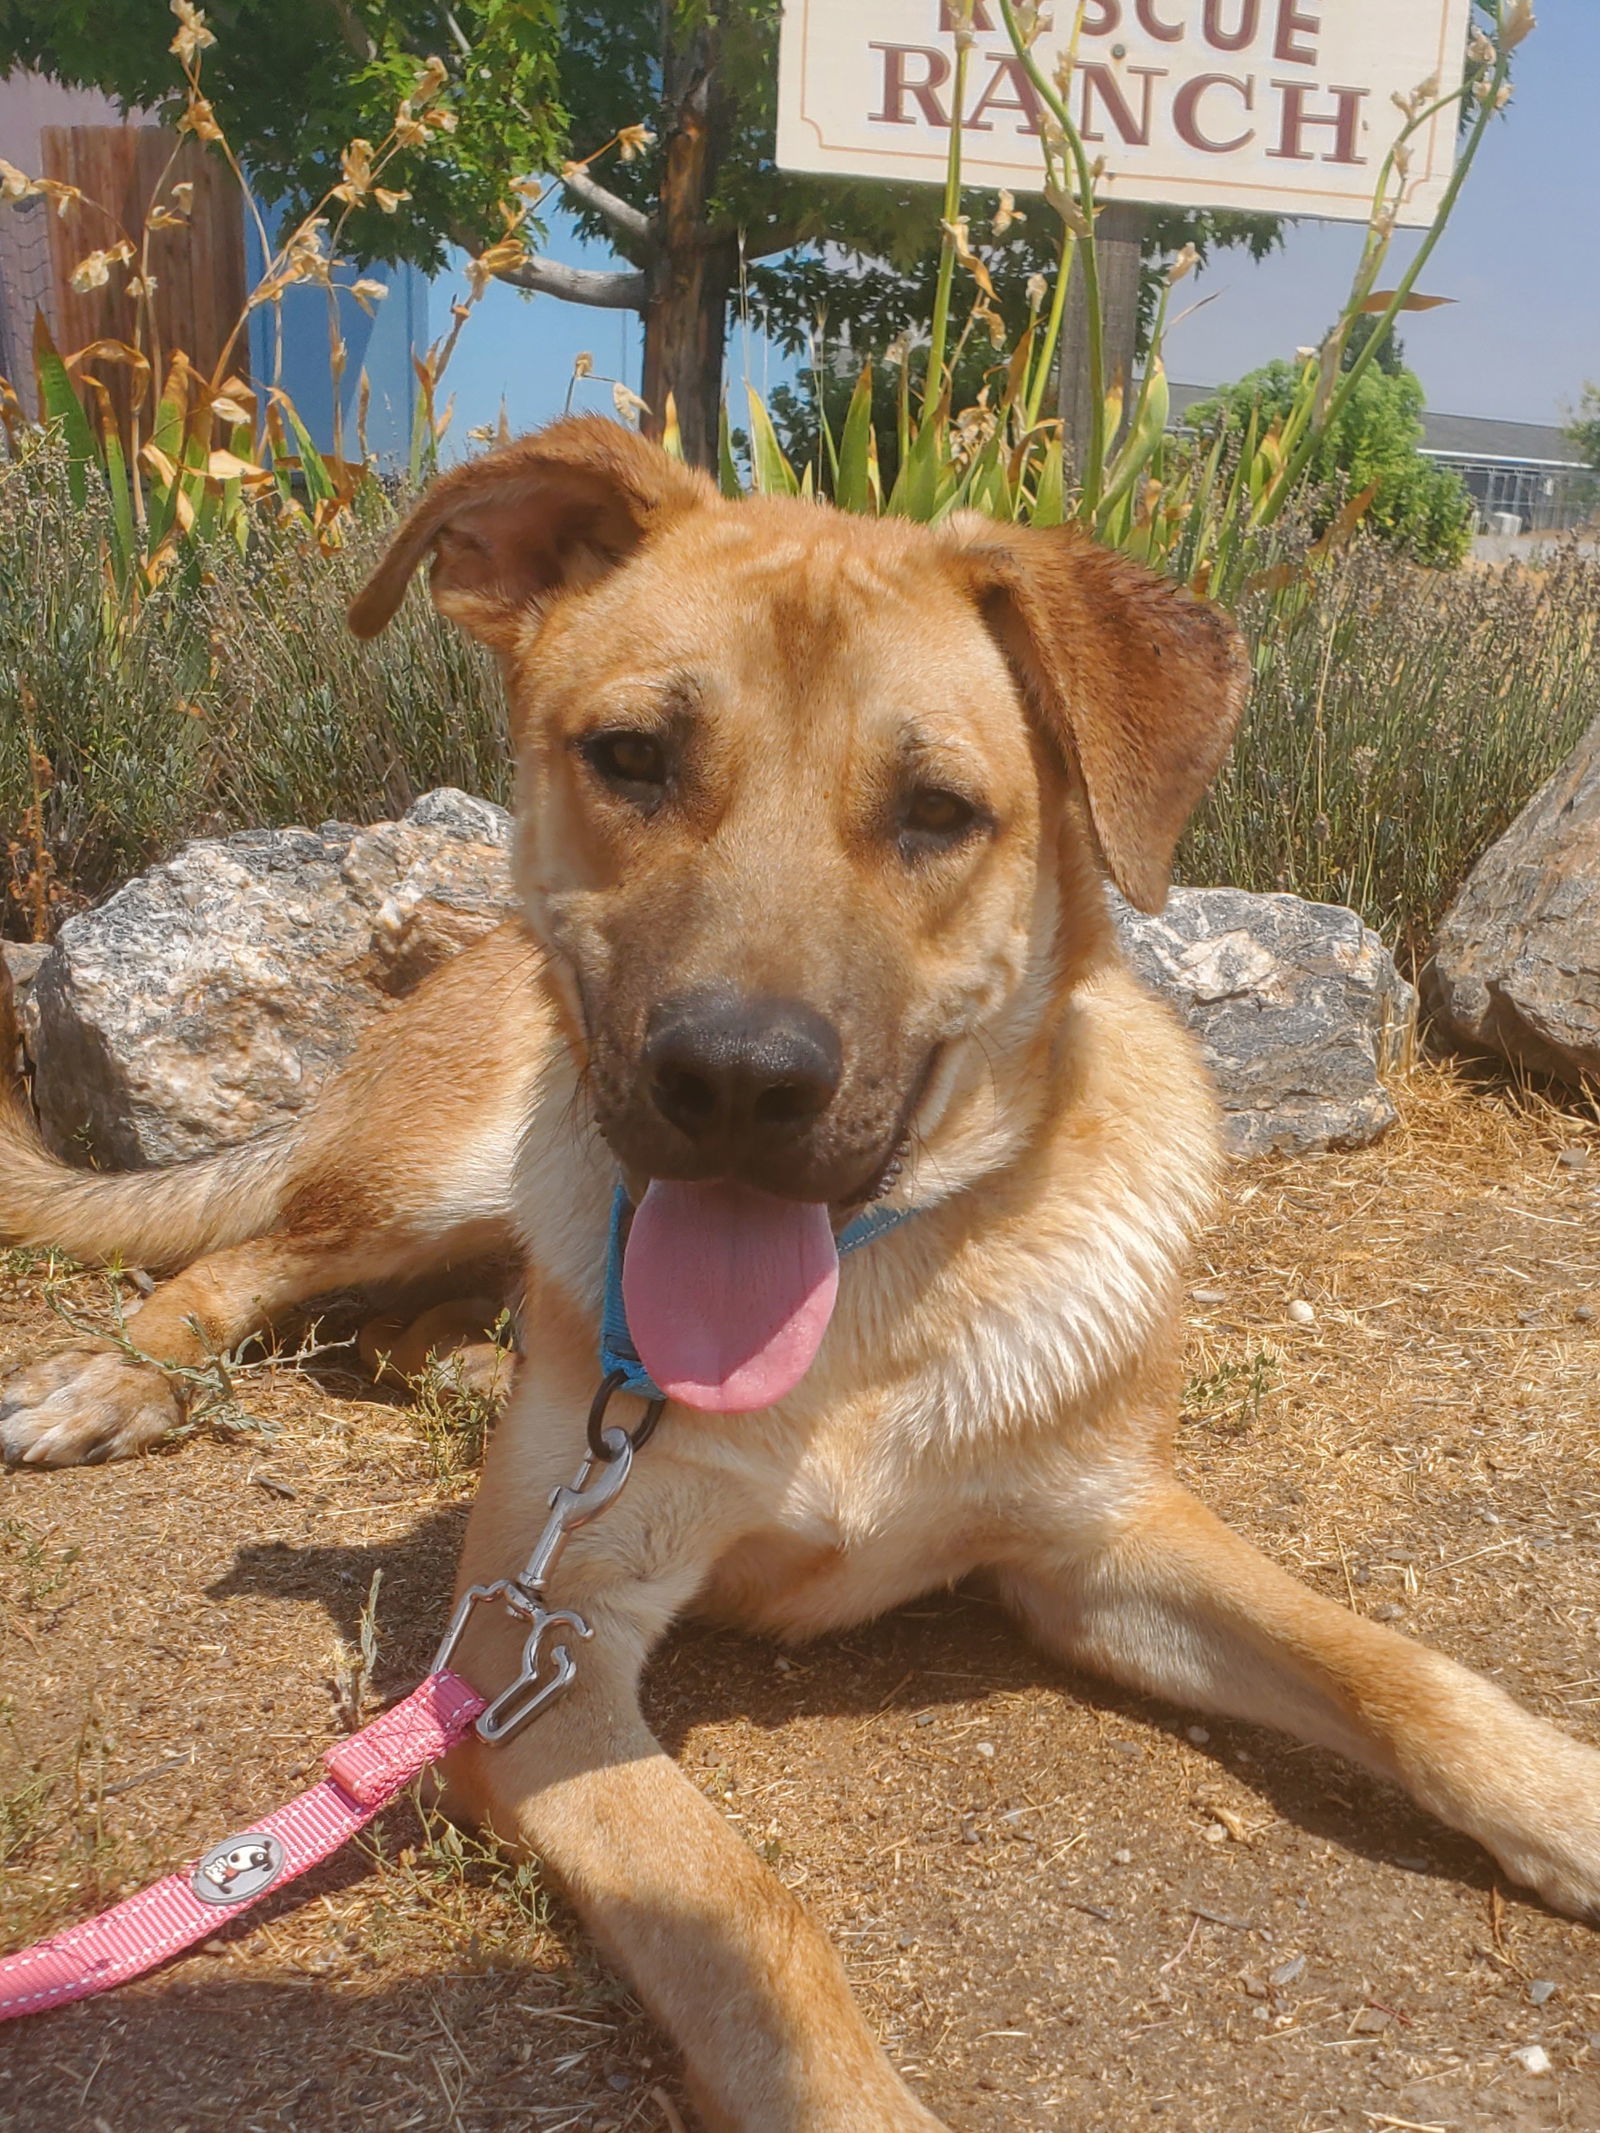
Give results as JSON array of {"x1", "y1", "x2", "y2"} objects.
[{"x1": 1180, "y1": 540, "x2": 1600, "y2": 960}]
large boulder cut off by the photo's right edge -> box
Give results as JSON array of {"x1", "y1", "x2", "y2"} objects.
[{"x1": 1423, "y1": 721, "x2": 1600, "y2": 1081}]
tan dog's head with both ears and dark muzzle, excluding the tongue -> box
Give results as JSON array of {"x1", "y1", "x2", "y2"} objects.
[{"x1": 352, "y1": 420, "x2": 1244, "y2": 1399}]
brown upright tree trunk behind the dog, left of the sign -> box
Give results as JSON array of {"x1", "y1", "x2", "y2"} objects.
[{"x1": 644, "y1": 0, "x2": 738, "y2": 467}]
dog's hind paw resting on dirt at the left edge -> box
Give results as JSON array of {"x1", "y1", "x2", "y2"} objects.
[{"x1": 0, "y1": 1348, "x2": 183, "y2": 1465}]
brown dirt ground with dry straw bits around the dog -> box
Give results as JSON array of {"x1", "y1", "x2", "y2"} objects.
[{"x1": 0, "y1": 1069, "x2": 1600, "y2": 2133}]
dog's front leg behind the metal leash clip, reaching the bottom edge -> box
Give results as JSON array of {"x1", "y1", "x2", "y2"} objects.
[{"x1": 444, "y1": 1404, "x2": 939, "y2": 2133}]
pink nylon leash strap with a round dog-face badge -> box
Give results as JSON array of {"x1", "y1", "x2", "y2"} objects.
[{"x1": 0, "y1": 1668, "x2": 486, "y2": 2022}]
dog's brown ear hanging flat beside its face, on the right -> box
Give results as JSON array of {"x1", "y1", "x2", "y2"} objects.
[{"x1": 951, "y1": 514, "x2": 1250, "y2": 911}]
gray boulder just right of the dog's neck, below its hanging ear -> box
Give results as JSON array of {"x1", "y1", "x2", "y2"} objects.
[{"x1": 1111, "y1": 889, "x2": 1417, "y2": 1156}]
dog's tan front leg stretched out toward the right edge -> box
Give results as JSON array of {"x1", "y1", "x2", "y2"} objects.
[{"x1": 1001, "y1": 1478, "x2": 1600, "y2": 1918}]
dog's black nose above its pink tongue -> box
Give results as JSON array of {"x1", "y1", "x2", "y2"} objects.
[{"x1": 644, "y1": 992, "x2": 845, "y2": 1158}]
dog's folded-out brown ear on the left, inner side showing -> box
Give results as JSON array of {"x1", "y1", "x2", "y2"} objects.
[{"x1": 350, "y1": 416, "x2": 715, "y2": 651}]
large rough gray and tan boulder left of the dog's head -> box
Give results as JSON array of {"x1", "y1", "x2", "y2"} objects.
[{"x1": 23, "y1": 791, "x2": 512, "y2": 1167}]
